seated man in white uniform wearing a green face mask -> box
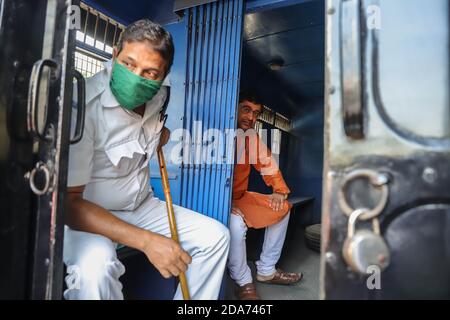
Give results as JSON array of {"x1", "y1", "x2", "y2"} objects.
[{"x1": 64, "y1": 20, "x2": 229, "y2": 299}]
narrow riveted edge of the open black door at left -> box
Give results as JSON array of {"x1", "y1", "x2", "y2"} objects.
[{"x1": 31, "y1": 1, "x2": 78, "y2": 299}]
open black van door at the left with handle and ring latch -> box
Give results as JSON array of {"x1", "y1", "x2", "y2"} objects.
[{"x1": 0, "y1": 0, "x2": 84, "y2": 299}]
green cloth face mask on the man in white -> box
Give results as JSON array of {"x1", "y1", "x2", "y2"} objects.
[{"x1": 109, "y1": 61, "x2": 162, "y2": 110}]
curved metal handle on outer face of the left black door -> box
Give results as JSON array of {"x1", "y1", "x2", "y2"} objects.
[{"x1": 27, "y1": 59, "x2": 58, "y2": 142}]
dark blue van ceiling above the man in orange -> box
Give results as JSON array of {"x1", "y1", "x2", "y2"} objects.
[{"x1": 242, "y1": 0, "x2": 325, "y2": 117}]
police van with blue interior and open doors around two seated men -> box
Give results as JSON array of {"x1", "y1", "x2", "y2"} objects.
[{"x1": 0, "y1": 0, "x2": 450, "y2": 300}]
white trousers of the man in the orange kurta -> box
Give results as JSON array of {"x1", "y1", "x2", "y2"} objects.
[{"x1": 228, "y1": 213, "x2": 290, "y2": 286}]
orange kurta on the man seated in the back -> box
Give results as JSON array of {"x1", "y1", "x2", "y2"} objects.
[{"x1": 233, "y1": 136, "x2": 292, "y2": 228}]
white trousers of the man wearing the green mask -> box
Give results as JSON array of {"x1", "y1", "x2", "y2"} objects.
[{"x1": 64, "y1": 196, "x2": 230, "y2": 300}]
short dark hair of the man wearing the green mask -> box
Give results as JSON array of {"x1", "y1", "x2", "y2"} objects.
[{"x1": 117, "y1": 19, "x2": 175, "y2": 72}]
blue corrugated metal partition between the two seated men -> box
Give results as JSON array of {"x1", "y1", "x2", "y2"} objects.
[{"x1": 181, "y1": 0, "x2": 243, "y2": 225}]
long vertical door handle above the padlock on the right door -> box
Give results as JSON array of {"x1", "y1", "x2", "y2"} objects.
[{"x1": 340, "y1": 0, "x2": 364, "y2": 139}]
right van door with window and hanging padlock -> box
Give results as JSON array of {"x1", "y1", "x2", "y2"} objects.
[{"x1": 321, "y1": 0, "x2": 450, "y2": 299}]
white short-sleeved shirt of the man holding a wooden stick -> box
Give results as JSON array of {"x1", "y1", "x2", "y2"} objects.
[{"x1": 67, "y1": 61, "x2": 167, "y2": 210}]
